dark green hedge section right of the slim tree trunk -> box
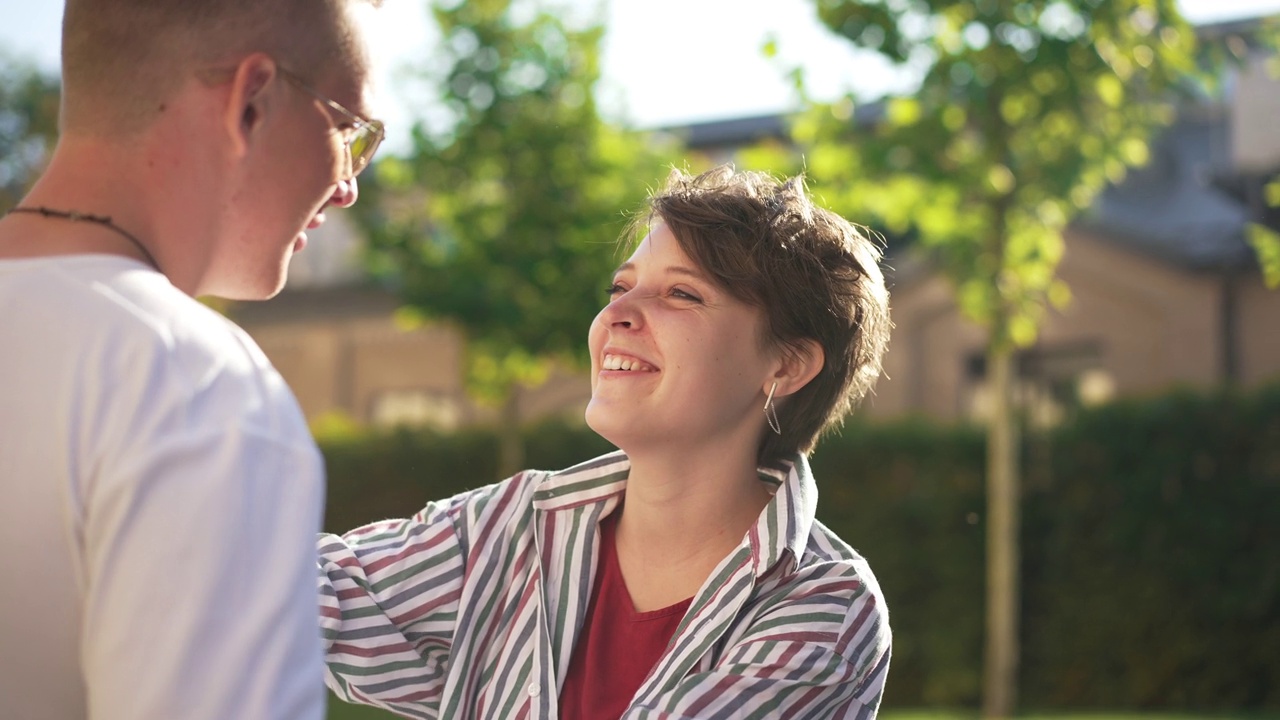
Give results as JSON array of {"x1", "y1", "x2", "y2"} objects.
[{"x1": 1023, "y1": 388, "x2": 1280, "y2": 710}]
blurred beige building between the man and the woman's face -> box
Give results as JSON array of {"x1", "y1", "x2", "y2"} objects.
[{"x1": 228, "y1": 210, "x2": 590, "y2": 430}]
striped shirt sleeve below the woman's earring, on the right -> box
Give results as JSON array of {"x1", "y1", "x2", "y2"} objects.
[{"x1": 623, "y1": 568, "x2": 891, "y2": 720}]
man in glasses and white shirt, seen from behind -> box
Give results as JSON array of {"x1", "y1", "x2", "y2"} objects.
[{"x1": 0, "y1": 0, "x2": 383, "y2": 720}]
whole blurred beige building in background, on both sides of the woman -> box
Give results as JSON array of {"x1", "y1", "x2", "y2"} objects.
[{"x1": 230, "y1": 19, "x2": 1280, "y2": 429}]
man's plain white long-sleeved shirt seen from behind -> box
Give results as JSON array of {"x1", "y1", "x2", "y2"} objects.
[{"x1": 0, "y1": 255, "x2": 324, "y2": 720}]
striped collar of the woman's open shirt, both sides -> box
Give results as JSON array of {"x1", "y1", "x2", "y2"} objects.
[{"x1": 534, "y1": 451, "x2": 818, "y2": 577}]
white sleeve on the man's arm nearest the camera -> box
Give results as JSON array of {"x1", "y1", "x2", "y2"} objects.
[{"x1": 81, "y1": 422, "x2": 325, "y2": 720}]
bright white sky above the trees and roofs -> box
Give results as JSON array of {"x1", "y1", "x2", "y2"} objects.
[{"x1": 0, "y1": 0, "x2": 1280, "y2": 154}]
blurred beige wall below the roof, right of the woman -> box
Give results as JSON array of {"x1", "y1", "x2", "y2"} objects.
[{"x1": 865, "y1": 233, "x2": 1280, "y2": 420}]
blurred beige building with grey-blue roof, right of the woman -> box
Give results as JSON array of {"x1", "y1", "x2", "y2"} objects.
[{"x1": 868, "y1": 99, "x2": 1280, "y2": 423}]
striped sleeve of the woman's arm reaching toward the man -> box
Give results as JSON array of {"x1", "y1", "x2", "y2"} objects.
[{"x1": 319, "y1": 491, "x2": 465, "y2": 716}]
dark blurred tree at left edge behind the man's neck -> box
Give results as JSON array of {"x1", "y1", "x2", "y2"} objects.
[{"x1": 0, "y1": 56, "x2": 60, "y2": 211}]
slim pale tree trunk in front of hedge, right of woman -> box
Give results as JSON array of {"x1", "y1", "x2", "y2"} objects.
[{"x1": 982, "y1": 343, "x2": 1020, "y2": 717}]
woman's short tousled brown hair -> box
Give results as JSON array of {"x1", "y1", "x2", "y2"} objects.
[{"x1": 637, "y1": 165, "x2": 891, "y2": 464}]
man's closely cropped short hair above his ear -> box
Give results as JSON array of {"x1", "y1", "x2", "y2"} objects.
[{"x1": 61, "y1": 0, "x2": 380, "y2": 135}]
